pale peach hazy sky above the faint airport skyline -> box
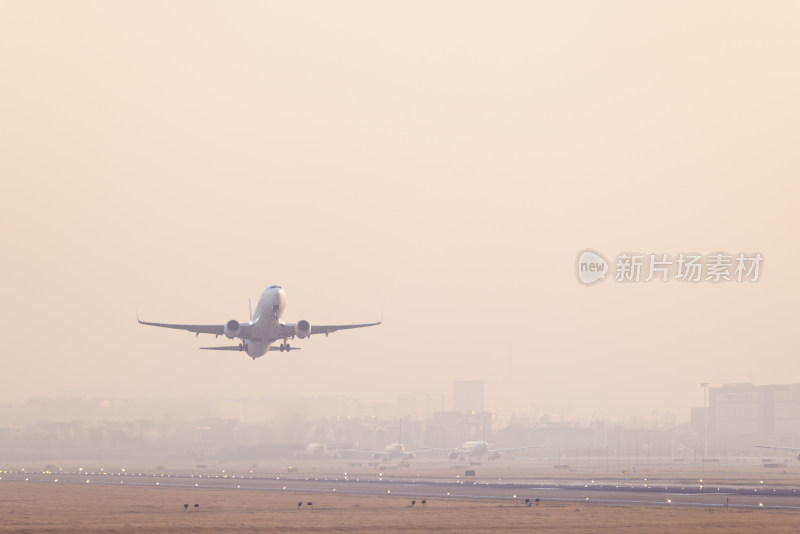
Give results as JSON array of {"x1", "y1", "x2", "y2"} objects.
[{"x1": 0, "y1": 1, "x2": 800, "y2": 419}]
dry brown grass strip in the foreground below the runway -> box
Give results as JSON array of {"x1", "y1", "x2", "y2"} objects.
[{"x1": 0, "y1": 482, "x2": 800, "y2": 533}]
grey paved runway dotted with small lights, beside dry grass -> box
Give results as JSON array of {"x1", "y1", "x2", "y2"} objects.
[{"x1": 0, "y1": 470, "x2": 800, "y2": 511}]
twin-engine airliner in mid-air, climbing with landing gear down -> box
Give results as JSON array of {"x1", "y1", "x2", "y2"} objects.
[{"x1": 136, "y1": 285, "x2": 383, "y2": 360}]
